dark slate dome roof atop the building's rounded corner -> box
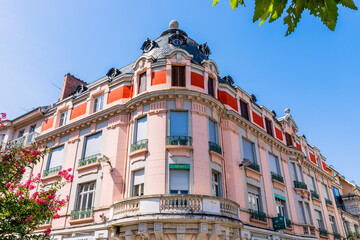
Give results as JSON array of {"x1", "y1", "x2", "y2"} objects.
[{"x1": 142, "y1": 29, "x2": 208, "y2": 64}]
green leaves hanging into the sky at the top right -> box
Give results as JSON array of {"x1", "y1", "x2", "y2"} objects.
[{"x1": 213, "y1": 0, "x2": 357, "y2": 36}]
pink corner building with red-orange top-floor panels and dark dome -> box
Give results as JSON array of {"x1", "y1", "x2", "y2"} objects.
[{"x1": 0, "y1": 21, "x2": 344, "y2": 240}]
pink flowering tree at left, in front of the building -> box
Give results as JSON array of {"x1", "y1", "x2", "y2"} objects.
[{"x1": 0, "y1": 113, "x2": 73, "y2": 240}]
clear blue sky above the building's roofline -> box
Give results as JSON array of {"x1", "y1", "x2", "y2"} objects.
[{"x1": 0, "y1": 0, "x2": 360, "y2": 184}]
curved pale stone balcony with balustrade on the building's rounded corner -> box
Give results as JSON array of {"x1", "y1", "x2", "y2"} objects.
[{"x1": 110, "y1": 194, "x2": 240, "y2": 221}]
